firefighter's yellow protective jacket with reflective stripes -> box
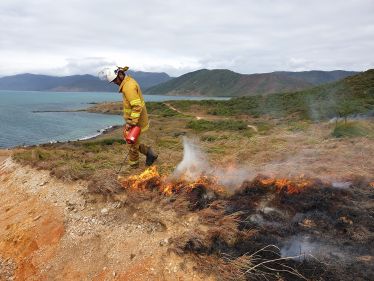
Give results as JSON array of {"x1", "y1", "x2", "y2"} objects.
[{"x1": 119, "y1": 75, "x2": 149, "y2": 132}]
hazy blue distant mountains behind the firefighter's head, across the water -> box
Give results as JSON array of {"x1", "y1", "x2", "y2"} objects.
[{"x1": 0, "y1": 71, "x2": 172, "y2": 92}]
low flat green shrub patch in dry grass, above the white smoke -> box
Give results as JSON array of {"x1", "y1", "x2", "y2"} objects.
[{"x1": 187, "y1": 120, "x2": 248, "y2": 132}]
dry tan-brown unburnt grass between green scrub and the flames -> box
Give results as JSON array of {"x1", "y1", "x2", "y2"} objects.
[{"x1": 14, "y1": 99, "x2": 374, "y2": 185}]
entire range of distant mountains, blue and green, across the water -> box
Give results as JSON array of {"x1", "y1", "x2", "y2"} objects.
[{"x1": 0, "y1": 69, "x2": 358, "y2": 94}]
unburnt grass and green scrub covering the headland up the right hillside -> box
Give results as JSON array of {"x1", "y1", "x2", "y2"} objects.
[{"x1": 14, "y1": 70, "x2": 374, "y2": 180}]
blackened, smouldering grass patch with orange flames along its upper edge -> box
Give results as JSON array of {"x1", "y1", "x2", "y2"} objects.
[{"x1": 113, "y1": 167, "x2": 374, "y2": 280}]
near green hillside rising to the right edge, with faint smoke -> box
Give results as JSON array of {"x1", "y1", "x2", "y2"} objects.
[{"x1": 169, "y1": 69, "x2": 374, "y2": 120}]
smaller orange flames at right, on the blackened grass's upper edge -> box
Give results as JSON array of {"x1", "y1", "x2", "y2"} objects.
[{"x1": 259, "y1": 177, "x2": 313, "y2": 194}]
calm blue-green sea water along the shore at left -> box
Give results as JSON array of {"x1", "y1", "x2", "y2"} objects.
[{"x1": 0, "y1": 91, "x2": 228, "y2": 148}]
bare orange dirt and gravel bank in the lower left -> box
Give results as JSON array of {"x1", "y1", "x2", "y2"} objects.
[{"x1": 0, "y1": 158, "x2": 207, "y2": 280}]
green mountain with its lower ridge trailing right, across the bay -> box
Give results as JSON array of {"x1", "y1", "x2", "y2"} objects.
[{"x1": 145, "y1": 69, "x2": 357, "y2": 97}]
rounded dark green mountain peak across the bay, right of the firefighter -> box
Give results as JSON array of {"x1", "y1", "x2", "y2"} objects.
[{"x1": 145, "y1": 69, "x2": 312, "y2": 97}]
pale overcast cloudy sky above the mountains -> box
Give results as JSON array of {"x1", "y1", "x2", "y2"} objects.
[{"x1": 0, "y1": 0, "x2": 374, "y2": 76}]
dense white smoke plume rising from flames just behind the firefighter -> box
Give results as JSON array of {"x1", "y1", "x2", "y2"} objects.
[{"x1": 172, "y1": 137, "x2": 253, "y2": 187}]
